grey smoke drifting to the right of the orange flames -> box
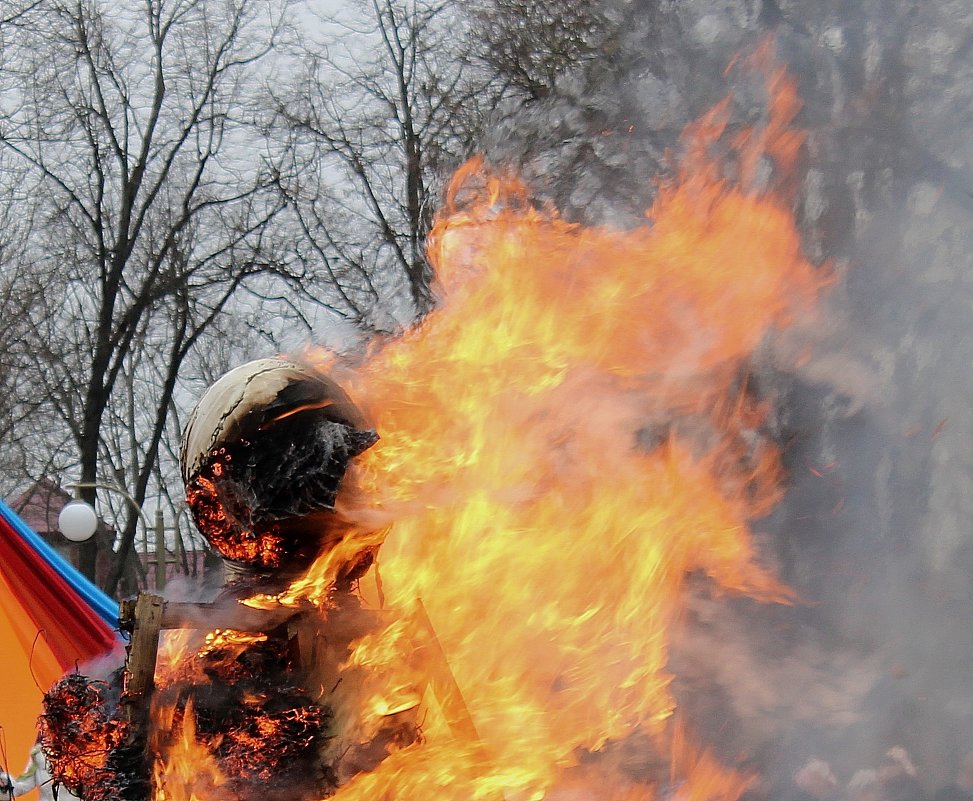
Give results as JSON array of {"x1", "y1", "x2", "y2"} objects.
[{"x1": 472, "y1": 0, "x2": 973, "y2": 786}]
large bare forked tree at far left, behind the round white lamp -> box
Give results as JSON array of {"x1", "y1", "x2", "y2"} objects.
[{"x1": 0, "y1": 0, "x2": 301, "y2": 591}]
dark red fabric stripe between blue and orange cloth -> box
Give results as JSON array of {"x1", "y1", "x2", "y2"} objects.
[{"x1": 0, "y1": 518, "x2": 118, "y2": 671}]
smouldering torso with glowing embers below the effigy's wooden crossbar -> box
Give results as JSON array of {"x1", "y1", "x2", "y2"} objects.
[{"x1": 149, "y1": 629, "x2": 327, "y2": 801}]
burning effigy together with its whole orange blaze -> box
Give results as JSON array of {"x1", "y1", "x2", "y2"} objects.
[{"x1": 38, "y1": 48, "x2": 828, "y2": 801}]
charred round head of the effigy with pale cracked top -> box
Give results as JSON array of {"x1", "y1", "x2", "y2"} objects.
[{"x1": 180, "y1": 359, "x2": 378, "y2": 571}]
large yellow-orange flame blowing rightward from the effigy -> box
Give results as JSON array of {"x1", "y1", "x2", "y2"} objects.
[{"x1": 300, "y1": 53, "x2": 816, "y2": 801}]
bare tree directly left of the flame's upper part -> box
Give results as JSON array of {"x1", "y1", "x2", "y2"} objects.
[{"x1": 274, "y1": 0, "x2": 498, "y2": 330}]
